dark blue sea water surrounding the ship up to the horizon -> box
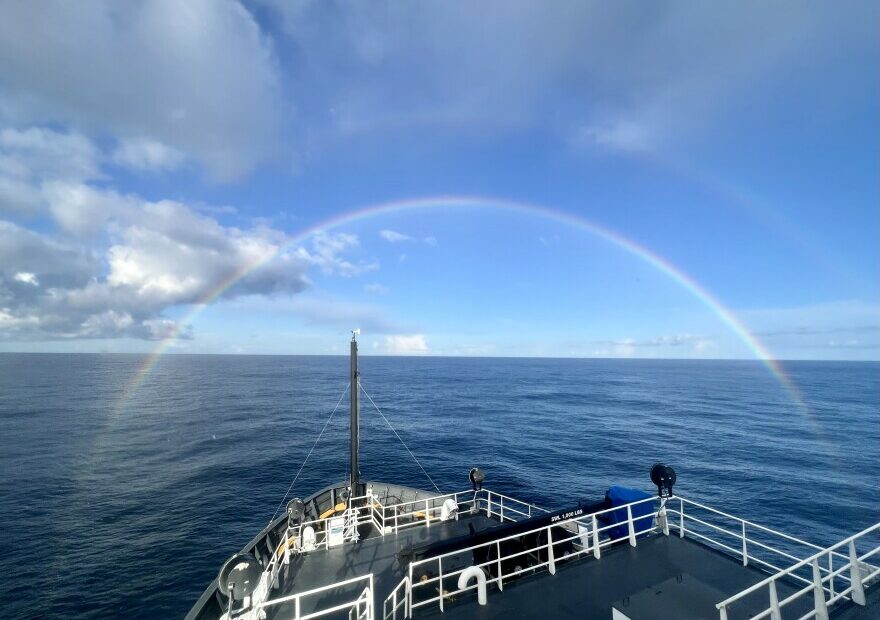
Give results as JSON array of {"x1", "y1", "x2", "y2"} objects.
[{"x1": 0, "y1": 354, "x2": 880, "y2": 618}]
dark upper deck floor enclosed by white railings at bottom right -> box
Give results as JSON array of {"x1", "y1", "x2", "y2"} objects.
[{"x1": 419, "y1": 534, "x2": 812, "y2": 620}]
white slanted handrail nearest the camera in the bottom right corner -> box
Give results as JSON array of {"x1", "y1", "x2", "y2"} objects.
[{"x1": 715, "y1": 523, "x2": 880, "y2": 620}]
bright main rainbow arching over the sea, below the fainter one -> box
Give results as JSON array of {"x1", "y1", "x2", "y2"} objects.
[{"x1": 110, "y1": 196, "x2": 821, "y2": 434}]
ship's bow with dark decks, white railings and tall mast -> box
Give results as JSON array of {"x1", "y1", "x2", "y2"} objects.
[{"x1": 186, "y1": 331, "x2": 880, "y2": 620}]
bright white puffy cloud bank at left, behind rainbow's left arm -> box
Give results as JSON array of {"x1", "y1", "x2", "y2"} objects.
[{"x1": 0, "y1": 128, "x2": 370, "y2": 340}]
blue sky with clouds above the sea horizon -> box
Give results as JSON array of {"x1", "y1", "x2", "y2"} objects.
[{"x1": 0, "y1": 0, "x2": 880, "y2": 359}]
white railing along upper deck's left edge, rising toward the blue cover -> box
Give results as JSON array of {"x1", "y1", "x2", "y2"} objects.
[{"x1": 402, "y1": 497, "x2": 661, "y2": 618}]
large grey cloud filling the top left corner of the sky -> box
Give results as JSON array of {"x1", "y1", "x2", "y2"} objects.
[{"x1": 0, "y1": 0, "x2": 284, "y2": 180}]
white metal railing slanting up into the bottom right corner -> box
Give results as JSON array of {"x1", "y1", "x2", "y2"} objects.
[{"x1": 716, "y1": 523, "x2": 880, "y2": 620}]
